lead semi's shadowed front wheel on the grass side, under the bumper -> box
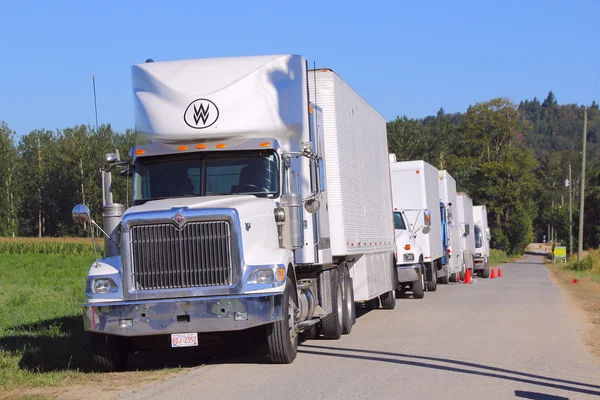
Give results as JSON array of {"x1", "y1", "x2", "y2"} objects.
[{"x1": 89, "y1": 333, "x2": 129, "y2": 372}]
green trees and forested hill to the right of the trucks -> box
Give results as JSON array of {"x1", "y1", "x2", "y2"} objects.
[{"x1": 388, "y1": 92, "x2": 600, "y2": 254}]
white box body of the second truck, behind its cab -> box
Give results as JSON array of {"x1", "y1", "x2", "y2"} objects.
[{"x1": 390, "y1": 160, "x2": 445, "y2": 291}]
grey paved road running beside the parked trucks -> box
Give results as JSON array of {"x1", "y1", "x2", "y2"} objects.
[{"x1": 117, "y1": 248, "x2": 600, "y2": 400}]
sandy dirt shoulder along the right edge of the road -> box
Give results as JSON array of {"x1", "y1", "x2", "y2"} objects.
[{"x1": 546, "y1": 262, "x2": 600, "y2": 361}]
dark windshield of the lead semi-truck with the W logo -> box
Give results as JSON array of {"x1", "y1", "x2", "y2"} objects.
[{"x1": 133, "y1": 151, "x2": 279, "y2": 205}]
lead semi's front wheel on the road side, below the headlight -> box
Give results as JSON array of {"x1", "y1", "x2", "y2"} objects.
[{"x1": 267, "y1": 279, "x2": 298, "y2": 364}]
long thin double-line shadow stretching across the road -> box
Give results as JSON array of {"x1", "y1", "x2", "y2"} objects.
[{"x1": 299, "y1": 345, "x2": 600, "y2": 399}]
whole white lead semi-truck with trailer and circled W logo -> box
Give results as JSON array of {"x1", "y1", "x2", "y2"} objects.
[{"x1": 73, "y1": 55, "x2": 397, "y2": 370}]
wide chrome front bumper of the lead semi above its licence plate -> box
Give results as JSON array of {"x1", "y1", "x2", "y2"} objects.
[{"x1": 83, "y1": 293, "x2": 283, "y2": 336}]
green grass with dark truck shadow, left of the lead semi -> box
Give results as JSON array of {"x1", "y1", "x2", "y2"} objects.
[{"x1": 0, "y1": 254, "x2": 93, "y2": 388}]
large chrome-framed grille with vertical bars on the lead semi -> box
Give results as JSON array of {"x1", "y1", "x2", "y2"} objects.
[{"x1": 131, "y1": 221, "x2": 232, "y2": 290}]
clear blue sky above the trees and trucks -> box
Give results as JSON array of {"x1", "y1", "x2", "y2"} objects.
[{"x1": 0, "y1": 0, "x2": 600, "y2": 134}]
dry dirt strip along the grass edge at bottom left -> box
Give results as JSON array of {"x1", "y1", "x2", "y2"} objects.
[{"x1": 0, "y1": 370, "x2": 175, "y2": 400}]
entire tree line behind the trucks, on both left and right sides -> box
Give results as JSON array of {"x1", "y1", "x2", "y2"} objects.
[{"x1": 0, "y1": 92, "x2": 600, "y2": 254}]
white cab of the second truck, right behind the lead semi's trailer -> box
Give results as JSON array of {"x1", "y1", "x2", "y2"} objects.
[{"x1": 394, "y1": 209, "x2": 425, "y2": 299}]
